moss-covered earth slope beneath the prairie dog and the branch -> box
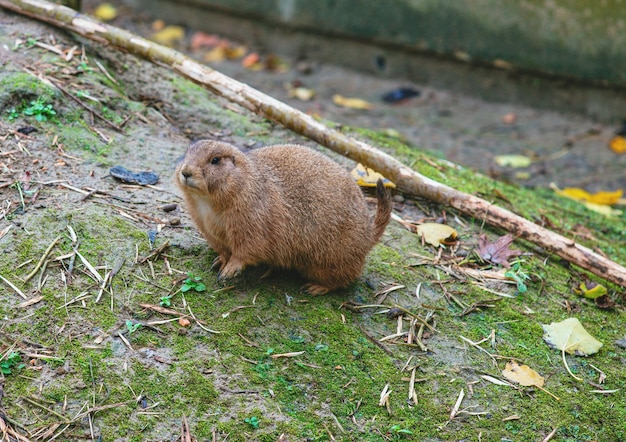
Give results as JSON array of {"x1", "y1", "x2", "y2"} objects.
[{"x1": 0, "y1": 11, "x2": 626, "y2": 441}]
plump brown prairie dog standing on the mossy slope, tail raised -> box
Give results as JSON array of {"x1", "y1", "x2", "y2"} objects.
[{"x1": 175, "y1": 141, "x2": 392, "y2": 294}]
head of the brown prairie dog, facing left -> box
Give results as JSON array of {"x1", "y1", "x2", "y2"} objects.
[{"x1": 175, "y1": 140, "x2": 249, "y2": 202}]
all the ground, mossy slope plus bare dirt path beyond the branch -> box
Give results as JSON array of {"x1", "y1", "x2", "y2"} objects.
[{"x1": 0, "y1": 2, "x2": 626, "y2": 442}]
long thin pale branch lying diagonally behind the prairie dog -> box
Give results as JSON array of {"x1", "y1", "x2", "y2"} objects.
[{"x1": 0, "y1": 0, "x2": 626, "y2": 287}]
